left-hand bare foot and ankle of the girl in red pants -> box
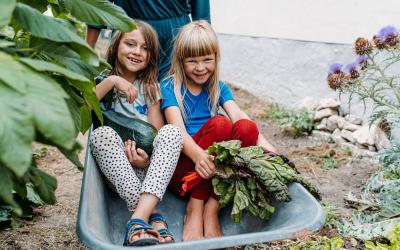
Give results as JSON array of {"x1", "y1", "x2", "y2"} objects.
[{"x1": 182, "y1": 198, "x2": 204, "y2": 241}]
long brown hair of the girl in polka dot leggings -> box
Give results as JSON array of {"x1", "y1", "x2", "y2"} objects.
[{"x1": 106, "y1": 20, "x2": 160, "y2": 103}]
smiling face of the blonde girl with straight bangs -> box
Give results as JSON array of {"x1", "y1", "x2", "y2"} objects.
[{"x1": 183, "y1": 54, "x2": 215, "y2": 85}]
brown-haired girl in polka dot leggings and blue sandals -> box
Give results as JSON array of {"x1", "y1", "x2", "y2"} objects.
[{"x1": 90, "y1": 20, "x2": 182, "y2": 246}]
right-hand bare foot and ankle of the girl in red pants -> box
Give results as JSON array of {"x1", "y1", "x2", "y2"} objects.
[{"x1": 203, "y1": 197, "x2": 224, "y2": 238}]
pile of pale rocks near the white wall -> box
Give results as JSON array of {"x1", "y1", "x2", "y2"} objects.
[{"x1": 301, "y1": 97, "x2": 390, "y2": 151}]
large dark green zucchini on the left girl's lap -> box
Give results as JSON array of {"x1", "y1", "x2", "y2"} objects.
[{"x1": 98, "y1": 110, "x2": 157, "y2": 157}]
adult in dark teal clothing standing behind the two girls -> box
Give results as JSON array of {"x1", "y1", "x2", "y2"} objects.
[{"x1": 86, "y1": 0, "x2": 210, "y2": 81}]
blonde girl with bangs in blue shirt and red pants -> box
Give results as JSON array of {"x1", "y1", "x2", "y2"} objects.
[{"x1": 161, "y1": 21, "x2": 275, "y2": 240}]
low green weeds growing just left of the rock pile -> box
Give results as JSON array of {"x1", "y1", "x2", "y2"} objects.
[{"x1": 266, "y1": 104, "x2": 315, "y2": 137}]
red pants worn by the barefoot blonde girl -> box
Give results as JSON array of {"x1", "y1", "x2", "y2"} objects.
[{"x1": 169, "y1": 116, "x2": 258, "y2": 200}]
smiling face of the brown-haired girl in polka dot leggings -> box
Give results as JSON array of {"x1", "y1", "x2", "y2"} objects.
[{"x1": 118, "y1": 29, "x2": 149, "y2": 76}]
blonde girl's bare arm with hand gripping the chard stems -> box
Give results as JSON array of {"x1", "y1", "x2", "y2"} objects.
[{"x1": 164, "y1": 106, "x2": 215, "y2": 179}]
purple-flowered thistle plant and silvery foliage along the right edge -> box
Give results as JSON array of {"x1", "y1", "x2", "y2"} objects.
[{"x1": 327, "y1": 26, "x2": 400, "y2": 240}]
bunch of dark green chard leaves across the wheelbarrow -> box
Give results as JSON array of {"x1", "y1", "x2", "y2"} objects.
[{"x1": 208, "y1": 140, "x2": 320, "y2": 223}]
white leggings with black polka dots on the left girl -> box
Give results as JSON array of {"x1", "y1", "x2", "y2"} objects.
[{"x1": 90, "y1": 125, "x2": 183, "y2": 211}]
